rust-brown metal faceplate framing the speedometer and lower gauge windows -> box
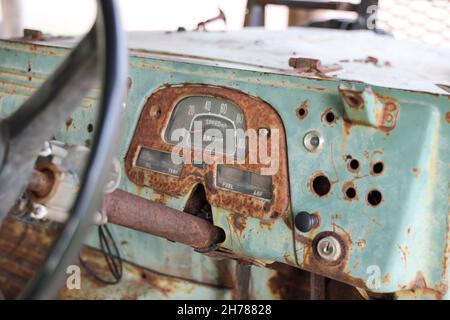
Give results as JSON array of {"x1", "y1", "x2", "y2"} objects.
[{"x1": 125, "y1": 84, "x2": 289, "y2": 219}]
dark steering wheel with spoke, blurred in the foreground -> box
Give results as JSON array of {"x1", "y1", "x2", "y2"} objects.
[{"x1": 0, "y1": 0, "x2": 128, "y2": 299}]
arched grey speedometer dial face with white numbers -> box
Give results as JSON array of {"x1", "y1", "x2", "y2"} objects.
[{"x1": 164, "y1": 96, "x2": 246, "y2": 157}]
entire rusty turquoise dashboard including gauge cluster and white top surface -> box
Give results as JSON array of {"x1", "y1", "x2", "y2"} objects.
[{"x1": 0, "y1": 28, "x2": 450, "y2": 298}]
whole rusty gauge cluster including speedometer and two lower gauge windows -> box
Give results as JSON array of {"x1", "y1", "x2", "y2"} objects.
[{"x1": 125, "y1": 84, "x2": 289, "y2": 219}]
